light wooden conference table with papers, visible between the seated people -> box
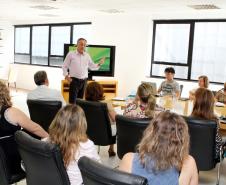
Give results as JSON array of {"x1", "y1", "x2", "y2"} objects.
[{"x1": 112, "y1": 96, "x2": 226, "y2": 131}]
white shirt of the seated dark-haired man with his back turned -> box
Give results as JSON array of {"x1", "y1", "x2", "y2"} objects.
[{"x1": 27, "y1": 85, "x2": 66, "y2": 106}]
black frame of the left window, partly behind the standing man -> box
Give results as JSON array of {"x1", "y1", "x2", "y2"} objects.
[{"x1": 14, "y1": 22, "x2": 92, "y2": 68}]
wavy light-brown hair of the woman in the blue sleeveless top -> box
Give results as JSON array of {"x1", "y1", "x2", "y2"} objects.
[{"x1": 138, "y1": 111, "x2": 189, "y2": 171}]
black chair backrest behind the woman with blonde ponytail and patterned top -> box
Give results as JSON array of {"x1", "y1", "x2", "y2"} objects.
[{"x1": 115, "y1": 115, "x2": 150, "y2": 159}]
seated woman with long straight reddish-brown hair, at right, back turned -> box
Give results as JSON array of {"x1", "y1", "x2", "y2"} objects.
[{"x1": 191, "y1": 88, "x2": 222, "y2": 159}]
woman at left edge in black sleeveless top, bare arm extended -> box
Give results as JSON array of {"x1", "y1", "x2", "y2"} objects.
[{"x1": 0, "y1": 81, "x2": 48, "y2": 138}]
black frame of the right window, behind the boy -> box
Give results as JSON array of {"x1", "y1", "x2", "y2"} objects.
[{"x1": 150, "y1": 19, "x2": 226, "y2": 84}]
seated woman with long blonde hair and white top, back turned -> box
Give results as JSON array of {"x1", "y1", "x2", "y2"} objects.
[{"x1": 46, "y1": 104, "x2": 100, "y2": 185}]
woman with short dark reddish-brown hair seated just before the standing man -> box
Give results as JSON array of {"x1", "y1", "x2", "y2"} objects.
[{"x1": 85, "y1": 82, "x2": 116, "y2": 157}]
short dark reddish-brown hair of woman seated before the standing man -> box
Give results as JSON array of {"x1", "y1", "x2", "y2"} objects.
[{"x1": 85, "y1": 82, "x2": 104, "y2": 101}]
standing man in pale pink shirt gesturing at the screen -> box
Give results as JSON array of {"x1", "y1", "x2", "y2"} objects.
[{"x1": 62, "y1": 38, "x2": 105, "y2": 103}]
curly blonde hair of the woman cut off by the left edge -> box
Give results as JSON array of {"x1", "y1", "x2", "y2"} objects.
[{"x1": 0, "y1": 81, "x2": 12, "y2": 108}]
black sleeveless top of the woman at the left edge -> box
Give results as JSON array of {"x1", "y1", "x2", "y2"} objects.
[{"x1": 0, "y1": 106, "x2": 21, "y2": 137}]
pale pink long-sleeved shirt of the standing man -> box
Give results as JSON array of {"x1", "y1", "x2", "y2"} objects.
[{"x1": 62, "y1": 51, "x2": 99, "y2": 79}]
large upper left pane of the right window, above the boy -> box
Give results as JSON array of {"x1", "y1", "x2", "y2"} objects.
[{"x1": 154, "y1": 24, "x2": 190, "y2": 64}]
